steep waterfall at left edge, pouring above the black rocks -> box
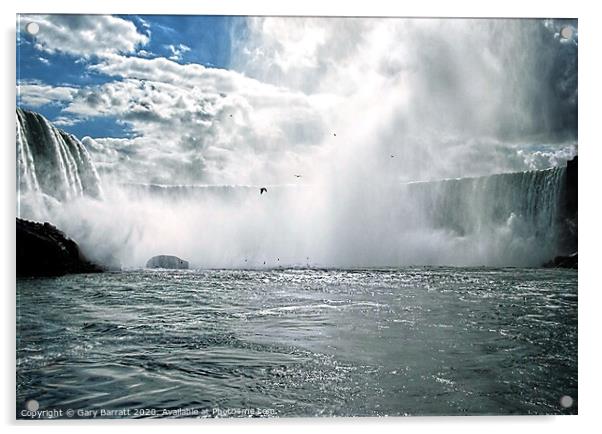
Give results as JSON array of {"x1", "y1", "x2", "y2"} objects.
[{"x1": 16, "y1": 109, "x2": 102, "y2": 219}]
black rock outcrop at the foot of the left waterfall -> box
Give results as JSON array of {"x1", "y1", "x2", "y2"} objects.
[{"x1": 17, "y1": 218, "x2": 103, "y2": 276}]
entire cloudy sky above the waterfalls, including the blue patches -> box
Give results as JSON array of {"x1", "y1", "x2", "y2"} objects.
[{"x1": 17, "y1": 15, "x2": 578, "y2": 185}]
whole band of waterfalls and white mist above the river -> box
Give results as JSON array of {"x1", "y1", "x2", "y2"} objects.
[{"x1": 17, "y1": 110, "x2": 566, "y2": 267}]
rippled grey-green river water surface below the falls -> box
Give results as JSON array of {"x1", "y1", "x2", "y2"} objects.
[{"x1": 17, "y1": 268, "x2": 577, "y2": 417}]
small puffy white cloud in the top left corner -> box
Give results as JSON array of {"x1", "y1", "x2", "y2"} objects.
[{"x1": 19, "y1": 14, "x2": 149, "y2": 58}]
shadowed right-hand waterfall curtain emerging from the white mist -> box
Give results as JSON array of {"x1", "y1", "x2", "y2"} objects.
[{"x1": 394, "y1": 167, "x2": 567, "y2": 265}]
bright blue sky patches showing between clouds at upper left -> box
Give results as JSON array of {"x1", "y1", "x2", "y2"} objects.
[{"x1": 17, "y1": 15, "x2": 244, "y2": 137}]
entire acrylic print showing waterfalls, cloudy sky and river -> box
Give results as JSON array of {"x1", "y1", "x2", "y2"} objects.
[{"x1": 15, "y1": 14, "x2": 578, "y2": 419}]
